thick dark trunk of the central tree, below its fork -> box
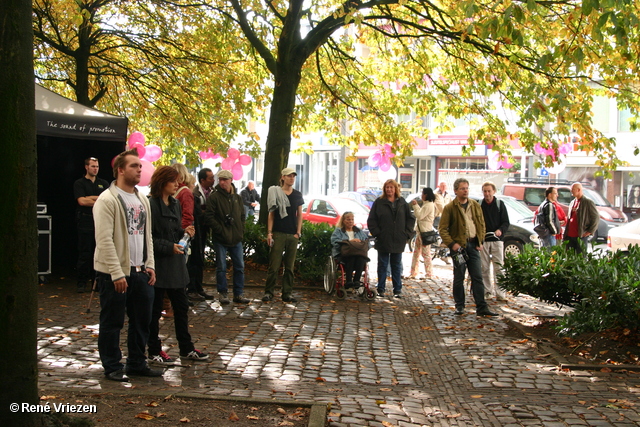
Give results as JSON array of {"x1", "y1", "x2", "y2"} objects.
[{"x1": 259, "y1": 64, "x2": 302, "y2": 224}]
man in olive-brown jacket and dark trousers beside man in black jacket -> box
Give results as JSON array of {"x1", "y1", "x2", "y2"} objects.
[{"x1": 438, "y1": 178, "x2": 497, "y2": 316}]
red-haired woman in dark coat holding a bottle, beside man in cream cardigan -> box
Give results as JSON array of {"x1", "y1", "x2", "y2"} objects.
[{"x1": 148, "y1": 166, "x2": 209, "y2": 364}]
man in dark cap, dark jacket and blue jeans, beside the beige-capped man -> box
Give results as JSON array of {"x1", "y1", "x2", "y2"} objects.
[{"x1": 204, "y1": 170, "x2": 249, "y2": 304}]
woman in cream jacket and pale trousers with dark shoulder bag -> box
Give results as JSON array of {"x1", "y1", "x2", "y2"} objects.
[{"x1": 409, "y1": 187, "x2": 436, "y2": 279}]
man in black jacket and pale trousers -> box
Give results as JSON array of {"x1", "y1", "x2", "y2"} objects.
[{"x1": 480, "y1": 181, "x2": 509, "y2": 301}]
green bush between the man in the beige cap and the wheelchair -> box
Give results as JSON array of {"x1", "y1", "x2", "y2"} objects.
[{"x1": 296, "y1": 221, "x2": 334, "y2": 283}]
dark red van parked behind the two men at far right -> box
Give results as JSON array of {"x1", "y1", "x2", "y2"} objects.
[{"x1": 502, "y1": 180, "x2": 628, "y2": 242}]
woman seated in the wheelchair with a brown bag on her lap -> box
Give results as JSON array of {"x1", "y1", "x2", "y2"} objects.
[{"x1": 331, "y1": 212, "x2": 369, "y2": 289}]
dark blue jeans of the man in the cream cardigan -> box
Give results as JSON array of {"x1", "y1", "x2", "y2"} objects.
[{"x1": 97, "y1": 271, "x2": 154, "y2": 374}]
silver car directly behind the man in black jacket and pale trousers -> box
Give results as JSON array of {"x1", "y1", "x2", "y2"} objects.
[{"x1": 469, "y1": 195, "x2": 540, "y2": 256}]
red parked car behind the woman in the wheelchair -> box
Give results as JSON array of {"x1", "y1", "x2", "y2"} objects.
[{"x1": 302, "y1": 196, "x2": 369, "y2": 234}]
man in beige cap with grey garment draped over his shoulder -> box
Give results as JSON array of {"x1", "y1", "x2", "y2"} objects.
[{"x1": 262, "y1": 167, "x2": 304, "y2": 302}]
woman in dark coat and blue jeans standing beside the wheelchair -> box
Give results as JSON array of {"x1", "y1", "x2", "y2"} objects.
[{"x1": 367, "y1": 179, "x2": 416, "y2": 298}]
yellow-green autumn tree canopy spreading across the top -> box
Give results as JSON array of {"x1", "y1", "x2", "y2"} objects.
[{"x1": 34, "y1": 0, "x2": 639, "y2": 181}]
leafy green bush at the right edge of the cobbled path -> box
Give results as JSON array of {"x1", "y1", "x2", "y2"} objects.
[{"x1": 498, "y1": 245, "x2": 640, "y2": 334}]
